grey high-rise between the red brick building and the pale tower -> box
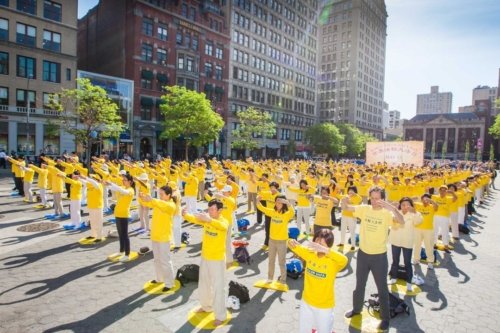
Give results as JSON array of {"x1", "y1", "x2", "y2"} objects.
[{"x1": 227, "y1": 0, "x2": 318, "y2": 158}]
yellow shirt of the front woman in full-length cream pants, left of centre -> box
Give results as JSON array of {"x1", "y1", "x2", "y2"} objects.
[{"x1": 184, "y1": 214, "x2": 229, "y2": 260}]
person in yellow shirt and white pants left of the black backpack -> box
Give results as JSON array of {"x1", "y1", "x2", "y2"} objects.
[{"x1": 139, "y1": 186, "x2": 177, "y2": 292}]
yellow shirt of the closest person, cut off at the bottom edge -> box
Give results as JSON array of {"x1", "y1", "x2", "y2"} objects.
[{"x1": 292, "y1": 245, "x2": 347, "y2": 309}]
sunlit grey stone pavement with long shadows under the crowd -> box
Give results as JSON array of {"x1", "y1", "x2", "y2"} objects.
[{"x1": 0, "y1": 174, "x2": 500, "y2": 333}]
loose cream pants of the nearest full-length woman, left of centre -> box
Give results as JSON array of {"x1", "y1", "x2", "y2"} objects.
[{"x1": 198, "y1": 258, "x2": 227, "y2": 321}]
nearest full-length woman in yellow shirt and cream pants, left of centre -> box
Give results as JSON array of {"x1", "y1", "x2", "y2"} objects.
[{"x1": 182, "y1": 199, "x2": 229, "y2": 326}]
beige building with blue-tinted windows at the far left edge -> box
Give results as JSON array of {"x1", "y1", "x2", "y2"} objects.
[{"x1": 0, "y1": 0, "x2": 77, "y2": 156}]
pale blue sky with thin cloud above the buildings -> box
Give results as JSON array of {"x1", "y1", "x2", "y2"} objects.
[{"x1": 78, "y1": 0, "x2": 500, "y2": 118}]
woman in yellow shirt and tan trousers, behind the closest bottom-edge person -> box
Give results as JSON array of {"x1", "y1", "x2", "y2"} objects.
[{"x1": 257, "y1": 195, "x2": 295, "y2": 284}]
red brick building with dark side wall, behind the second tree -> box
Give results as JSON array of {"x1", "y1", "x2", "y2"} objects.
[{"x1": 78, "y1": 0, "x2": 230, "y2": 158}]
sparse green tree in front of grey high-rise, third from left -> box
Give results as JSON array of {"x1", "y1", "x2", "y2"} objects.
[{"x1": 231, "y1": 107, "x2": 276, "y2": 155}]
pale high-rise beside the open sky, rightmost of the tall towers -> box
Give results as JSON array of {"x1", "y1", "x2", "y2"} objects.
[{"x1": 318, "y1": 0, "x2": 387, "y2": 139}]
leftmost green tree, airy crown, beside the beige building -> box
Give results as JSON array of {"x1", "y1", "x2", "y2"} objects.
[{"x1": 49, "y1": 78, "x2": 124, "y2": 164}]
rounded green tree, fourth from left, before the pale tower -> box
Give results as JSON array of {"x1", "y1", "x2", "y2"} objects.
[{"x1": 305, "y1": 123, "x2": 346, "y2": 157}]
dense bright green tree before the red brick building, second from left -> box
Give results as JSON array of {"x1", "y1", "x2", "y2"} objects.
[{"x1": 160, "y1": 86, "x2": 224, "y2": 160}]
